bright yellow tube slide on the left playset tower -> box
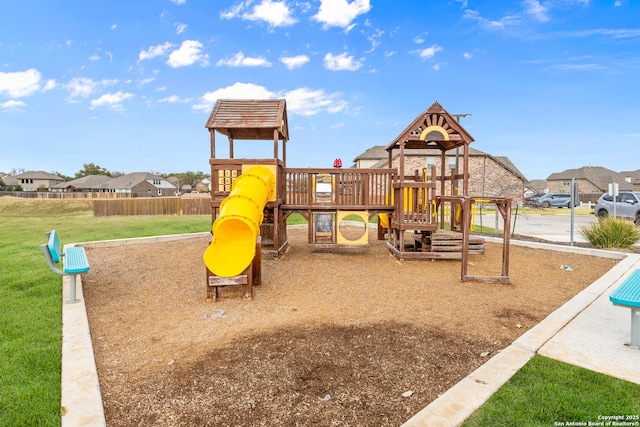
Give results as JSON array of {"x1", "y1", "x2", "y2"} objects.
[{"x1": 202, "y1": 166, "x2": 275, "y2": 277}]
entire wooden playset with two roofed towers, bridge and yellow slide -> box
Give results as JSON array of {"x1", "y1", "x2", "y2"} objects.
[{"x1": 203, "y1": 99, "x2": 511, "y2": 299}]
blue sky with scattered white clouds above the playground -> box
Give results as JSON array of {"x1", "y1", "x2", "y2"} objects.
[{"x1": 0, "y1": 0, "x2": 640, "y2": 179}]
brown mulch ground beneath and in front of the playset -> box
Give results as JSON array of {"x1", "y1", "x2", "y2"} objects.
[{"x1": 83, "y1": 227, "x2": 617, "y2": 426}]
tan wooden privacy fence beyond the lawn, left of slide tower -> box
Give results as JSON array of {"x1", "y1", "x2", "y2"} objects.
[{"x1": 93, "y1": 197, "x2": 211, "y2": 216}]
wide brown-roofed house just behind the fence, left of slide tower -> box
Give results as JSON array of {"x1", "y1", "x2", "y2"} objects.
[{"x1": 100, "y1": 172, "x2": 178, "y2": 197}]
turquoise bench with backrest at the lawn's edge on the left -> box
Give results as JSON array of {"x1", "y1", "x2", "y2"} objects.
[{"x1": 42, "y1": 230, "x2": 90, "y2": 303}]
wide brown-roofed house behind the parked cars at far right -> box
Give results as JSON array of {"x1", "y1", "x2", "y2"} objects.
[{"x1": 547, "y1": 166, "x2": 633, "y2": 194}]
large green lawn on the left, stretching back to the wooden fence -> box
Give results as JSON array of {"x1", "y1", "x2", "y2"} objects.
[{"x1": 0, "y1": 197, "x2": 211, "y2": 427}]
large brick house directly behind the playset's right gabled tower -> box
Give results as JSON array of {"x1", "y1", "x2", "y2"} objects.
[{"x1": 354, "y1": 147, "x2": 527, "y2": 205}]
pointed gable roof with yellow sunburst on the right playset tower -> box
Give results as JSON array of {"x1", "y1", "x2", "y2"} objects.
[{"x1": 386, "y1": 102, "x2": 473, "y2": 151}]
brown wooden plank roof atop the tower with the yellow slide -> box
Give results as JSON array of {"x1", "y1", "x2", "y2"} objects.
[{"x1": 206, "y1": 99, "x2": 289, "y2": 141}]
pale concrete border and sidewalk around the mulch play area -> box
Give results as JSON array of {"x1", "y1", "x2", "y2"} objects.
[{"x1": 61, "y1": 233, "x2": 640, "y2": 427}]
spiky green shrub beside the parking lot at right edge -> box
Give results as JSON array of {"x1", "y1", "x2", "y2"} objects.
[{"x1": 580, "y1": 217, "x2": 640, "y2": 249}]
